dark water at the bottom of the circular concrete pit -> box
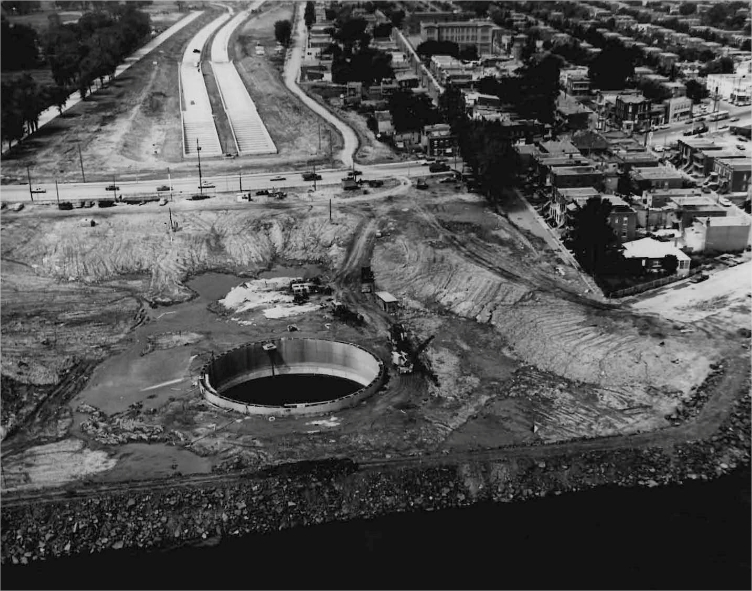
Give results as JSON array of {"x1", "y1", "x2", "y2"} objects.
[{"x1": 222, "y1": 374, "x2": 362, "y2": 406}]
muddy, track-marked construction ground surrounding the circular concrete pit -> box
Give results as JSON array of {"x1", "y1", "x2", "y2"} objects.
[{"x1": 0, "y1": 180, "x2": 750, "y2": 488}]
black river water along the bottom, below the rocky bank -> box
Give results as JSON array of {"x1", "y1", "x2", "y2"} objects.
[{"x1": 2, "y1": 468, "x2": 752, "y2": 589}]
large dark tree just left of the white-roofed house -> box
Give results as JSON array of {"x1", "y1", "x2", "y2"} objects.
[{"x1": 567, "y1": 197, "x2": 622, "y2": 273}]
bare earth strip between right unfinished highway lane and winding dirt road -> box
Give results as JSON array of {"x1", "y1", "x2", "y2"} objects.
[{"x1": 230, "y1": 3, "x2": 342, "y2": 168}]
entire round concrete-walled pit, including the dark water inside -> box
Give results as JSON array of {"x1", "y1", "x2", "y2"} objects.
[{"x1": 199, "y1": 338, "x2": 385, "y2": 416}]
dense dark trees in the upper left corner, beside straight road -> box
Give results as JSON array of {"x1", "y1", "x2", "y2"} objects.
[{"x1": 0, "y1": 2, "x2": 151, "y2": 147}]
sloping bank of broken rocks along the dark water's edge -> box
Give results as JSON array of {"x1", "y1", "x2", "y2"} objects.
[{"x1": 0, "y1": 384, "x2": 750, "y2": 565}]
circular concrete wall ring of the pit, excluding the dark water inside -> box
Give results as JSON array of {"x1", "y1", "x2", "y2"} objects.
[{"x1": 199, "y1": 338, "x2": 385, "y2": 416}]
